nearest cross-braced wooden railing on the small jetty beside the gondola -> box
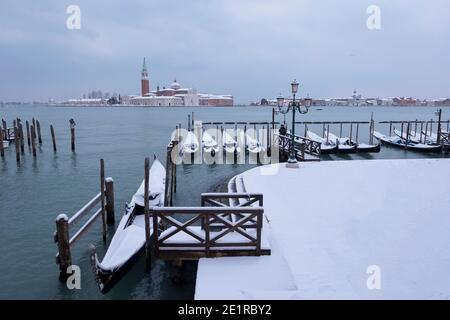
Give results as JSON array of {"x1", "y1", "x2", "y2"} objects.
[{"x1": 150, "y1": 207, "x2": 267, "y2": 258}]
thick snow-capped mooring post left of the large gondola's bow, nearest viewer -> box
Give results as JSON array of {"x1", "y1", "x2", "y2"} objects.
[{"x1": 55, "y1": 214, "x2": 72, "y2": 279}]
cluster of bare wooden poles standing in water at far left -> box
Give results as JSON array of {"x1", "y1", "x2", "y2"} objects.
[{"x1": 0, "y1": 118, "x2": 75, "y2": 163}]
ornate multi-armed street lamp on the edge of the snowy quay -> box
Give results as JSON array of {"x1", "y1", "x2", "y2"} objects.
[{"x1": 277, "y1": 79, "x2": 312, "y2": 168}]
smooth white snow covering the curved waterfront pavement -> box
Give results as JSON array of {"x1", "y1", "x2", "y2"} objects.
[{"x1": 195, "y1": 159, "x2": 450, "y2": 299}]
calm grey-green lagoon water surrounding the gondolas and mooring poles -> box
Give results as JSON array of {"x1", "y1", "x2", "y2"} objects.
[{"x1": 0, "y1": 105, "x2": 450, "y2": 299}]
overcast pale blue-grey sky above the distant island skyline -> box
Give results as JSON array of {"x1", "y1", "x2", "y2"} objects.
[{"x1": 0, "y1": 0, "x2": 450, "y2": 103}]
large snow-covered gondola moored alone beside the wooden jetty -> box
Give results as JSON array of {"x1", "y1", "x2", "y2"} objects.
[{"x1": 91, "y1": 159, "x2": 166, "y2": 293}]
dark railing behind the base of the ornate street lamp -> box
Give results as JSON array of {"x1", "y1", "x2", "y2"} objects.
[{"x1": 274, "y1": 133, "x2": 321, "y2": 160}]
